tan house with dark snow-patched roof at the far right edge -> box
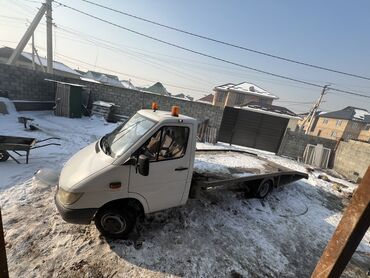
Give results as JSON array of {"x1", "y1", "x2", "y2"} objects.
[{"x1": 309, "y1": 106, "x2": 370, "y2": 141}]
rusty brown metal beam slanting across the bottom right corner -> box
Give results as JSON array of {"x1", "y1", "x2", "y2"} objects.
[{"x1": 311, "y1": 166, "x2": 370, "y2": 278}]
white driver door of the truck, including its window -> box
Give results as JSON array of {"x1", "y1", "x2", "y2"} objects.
[{"x1": 129, "y1": 125, "x2": 192, "y2": 212}]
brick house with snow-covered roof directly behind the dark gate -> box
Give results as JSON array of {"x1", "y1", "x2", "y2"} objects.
[{"x1": 213, "y1": 82, "x2": 278, "y2": 107}]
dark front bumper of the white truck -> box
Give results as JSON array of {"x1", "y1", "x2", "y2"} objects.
[{"x1": 54, "y1": 195, "x2": 97, "y2": 224}]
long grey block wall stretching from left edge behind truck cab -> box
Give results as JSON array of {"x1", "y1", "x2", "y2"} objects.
[{"x1": 0, "y1": 64, "x2": 223, "y2": 128}]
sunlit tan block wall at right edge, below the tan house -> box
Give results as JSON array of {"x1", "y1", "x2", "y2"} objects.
[{"x1": 334, "y1": 140, "x2": 370, "y2": 179}]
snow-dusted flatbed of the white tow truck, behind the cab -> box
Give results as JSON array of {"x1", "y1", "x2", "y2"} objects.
[{"x1": 190, "y1": 149, "x2": 308, "y2": 197}]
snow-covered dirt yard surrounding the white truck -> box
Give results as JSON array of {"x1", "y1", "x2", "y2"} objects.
[{"x1": 0, "y1": 109, "x2": 370, "y2": 277}]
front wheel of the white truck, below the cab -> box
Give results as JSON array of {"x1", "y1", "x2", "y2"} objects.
[{"x1": 95, "y1": 206, "x2": 136, "y2": 239}]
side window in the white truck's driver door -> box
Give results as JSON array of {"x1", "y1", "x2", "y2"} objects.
[{"x1": 138, "y1": 126, "x2": 189, "y2": 161}]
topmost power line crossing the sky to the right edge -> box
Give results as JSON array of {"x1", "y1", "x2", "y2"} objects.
[{"x1": 79, "y1": 0, "x2": 370, "y2": 80}]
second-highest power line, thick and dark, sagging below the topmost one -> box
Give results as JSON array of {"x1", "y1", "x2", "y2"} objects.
[{"x1": 54, "y1": 0, "x2": 370, "y2": 98}]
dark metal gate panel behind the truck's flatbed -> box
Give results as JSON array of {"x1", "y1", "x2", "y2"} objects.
[{"x1": 218, "y1": 107, "x2": 289, "y2": 153}]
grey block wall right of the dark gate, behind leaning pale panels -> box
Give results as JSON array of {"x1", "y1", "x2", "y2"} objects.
[{"x1": 278, "y1": 130, "x2": 337, "y2": 161}]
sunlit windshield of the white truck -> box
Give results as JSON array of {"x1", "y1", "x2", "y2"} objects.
[{"x1": 104, "y1": 114, "x2": 155, "y2": 157}]
